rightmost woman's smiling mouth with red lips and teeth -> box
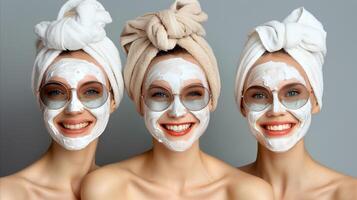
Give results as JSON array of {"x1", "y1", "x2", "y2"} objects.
[{"x1": 260, "y1": 122, "x2": 296, "y2": 137}]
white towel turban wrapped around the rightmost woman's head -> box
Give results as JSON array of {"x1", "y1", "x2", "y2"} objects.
[{"x1": 235, "y1": 8, "x2": 326, "y2": 112}]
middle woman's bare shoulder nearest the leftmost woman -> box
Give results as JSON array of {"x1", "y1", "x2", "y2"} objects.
[{"x1": 81, "y1": 152, "x2": 148, "y2": 200}]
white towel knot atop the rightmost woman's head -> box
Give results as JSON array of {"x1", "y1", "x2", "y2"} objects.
[{"x1": 255, "y1": 8, "x2": 326, "y2": 55}]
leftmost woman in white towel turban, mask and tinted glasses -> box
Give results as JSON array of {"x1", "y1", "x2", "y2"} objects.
[{"x1": 0, "y1": 0, "x2": 124, "y2": 200}]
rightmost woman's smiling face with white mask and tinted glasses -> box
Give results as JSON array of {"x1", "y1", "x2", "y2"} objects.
[{"x1": 242, "y1": 52, "x2": 317, "y2": 152}]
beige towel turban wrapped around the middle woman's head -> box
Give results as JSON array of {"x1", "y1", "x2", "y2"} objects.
[{"x1": 120, "y1": 0, "x2": 220, "y2": 114}]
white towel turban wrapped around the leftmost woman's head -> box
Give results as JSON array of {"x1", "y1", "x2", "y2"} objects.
[{"x1": 32, "y1": 0, "x2": 124, "y2": 107}]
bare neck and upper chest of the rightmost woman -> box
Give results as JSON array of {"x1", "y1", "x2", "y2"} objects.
[{"x1": 254, "y1": 140, "x2": 313, "y2": 193}]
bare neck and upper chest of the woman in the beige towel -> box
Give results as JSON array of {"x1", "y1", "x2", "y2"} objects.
[{"x1": 148, "y1": 140, "x2": 211, "y2": 189}]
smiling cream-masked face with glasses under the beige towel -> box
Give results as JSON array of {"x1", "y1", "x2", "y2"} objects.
[{"x1": 142, "y1": 51, "x2": 211, "y2": 151}]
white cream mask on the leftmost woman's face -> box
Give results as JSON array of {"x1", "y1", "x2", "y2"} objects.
[{"x1": 43, "y1": 58, "x2": 110, "y2": 150}]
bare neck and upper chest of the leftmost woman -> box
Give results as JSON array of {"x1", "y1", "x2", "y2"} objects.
[{"x1": 36, "y1": 140, "x2": 98, "y2": 195}]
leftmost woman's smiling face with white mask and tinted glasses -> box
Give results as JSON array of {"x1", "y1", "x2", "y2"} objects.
[{"x1": 40, "y1": 52, "x2": 114, "y2": 150}]
